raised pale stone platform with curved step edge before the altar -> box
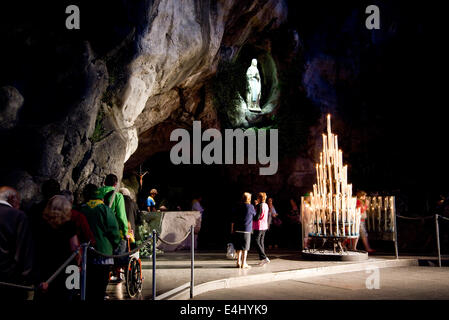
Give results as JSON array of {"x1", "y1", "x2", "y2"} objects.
[{"x1": 108, "y1": 251, "x2": 418, "y2": 300}]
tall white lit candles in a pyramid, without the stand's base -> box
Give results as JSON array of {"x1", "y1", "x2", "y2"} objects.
[{"x1": 309, "y1": 115, "x2": 360, "y2": 237}]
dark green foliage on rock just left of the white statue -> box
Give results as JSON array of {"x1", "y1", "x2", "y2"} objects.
[{"x1": 211, "y1": 61, "x2": 248, "y2": 128}]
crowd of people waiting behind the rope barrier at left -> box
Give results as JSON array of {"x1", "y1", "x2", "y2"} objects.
[{"x1": 0, "y1": 174, "x2": 152, "y2": 300}]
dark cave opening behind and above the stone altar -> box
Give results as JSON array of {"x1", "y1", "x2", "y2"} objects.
[{"x1": 124, "y1": 151, "x2": 240, "y2": 250}]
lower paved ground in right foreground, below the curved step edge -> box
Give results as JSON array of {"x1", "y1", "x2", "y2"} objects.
[{"x1": 194, "y1": 267, "x2": 449, "y2": 300}]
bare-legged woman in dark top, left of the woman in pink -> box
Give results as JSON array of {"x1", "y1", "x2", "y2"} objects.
[{"x1": 231, "y1": 192, "x2": 256, "y2": 269}]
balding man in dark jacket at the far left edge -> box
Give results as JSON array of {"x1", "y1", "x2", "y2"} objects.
[{"x1": 0, "y1": 187, "x2": 33, "y2": 301}]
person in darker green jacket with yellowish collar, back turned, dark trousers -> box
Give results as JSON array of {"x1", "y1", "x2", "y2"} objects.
[{"x1": 80, "y1": 184, "x2": 120, "y2": 300}]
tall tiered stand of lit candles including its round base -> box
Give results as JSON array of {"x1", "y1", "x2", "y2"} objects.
[{"x1": 301, "y1": 115, "x2": 368, "y2": 260}]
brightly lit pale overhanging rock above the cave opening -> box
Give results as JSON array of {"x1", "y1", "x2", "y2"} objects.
[{"x1": 117, "y1": 0, "x2": 286, "y2": 160}]
